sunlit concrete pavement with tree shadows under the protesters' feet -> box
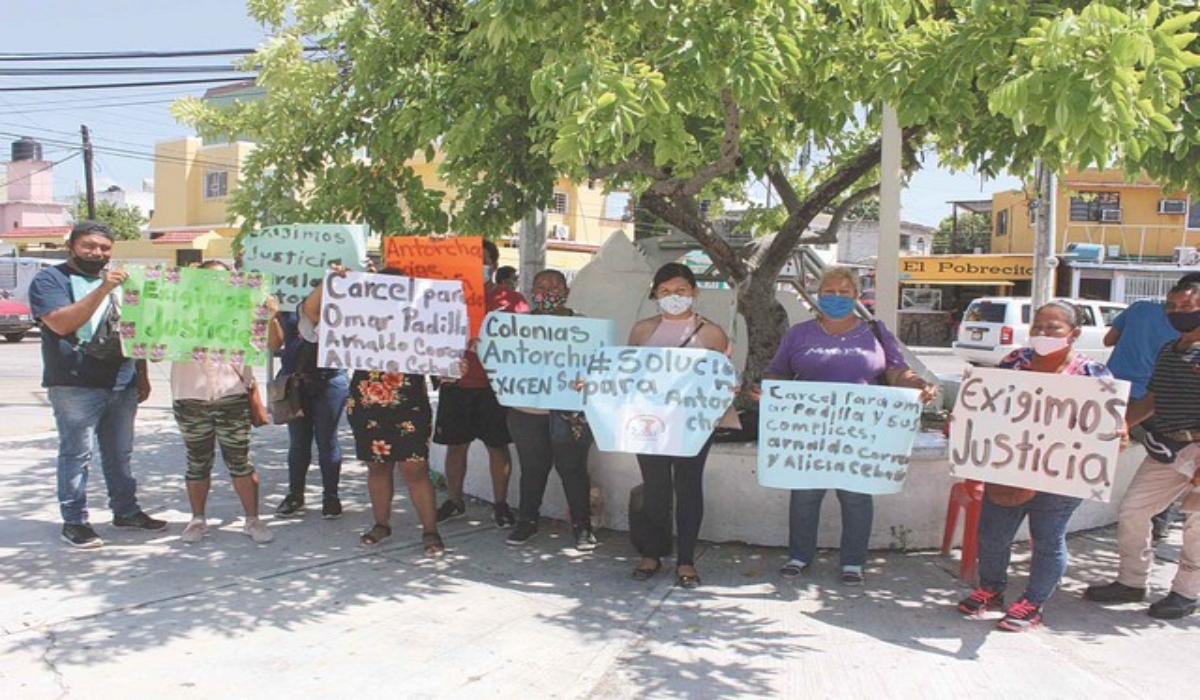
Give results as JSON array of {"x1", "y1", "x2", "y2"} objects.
[{"x1": 0, "y1": 417, "x2": 1200, "y2": 700}]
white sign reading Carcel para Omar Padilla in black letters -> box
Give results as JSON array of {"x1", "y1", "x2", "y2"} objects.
[{"x1": 317, "y1": 273, "x2": 467, "y2": 377}]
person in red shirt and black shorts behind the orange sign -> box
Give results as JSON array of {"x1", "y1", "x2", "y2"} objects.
[{"x1": 433, "y1": 240, "x2": 529, "y2": 528}]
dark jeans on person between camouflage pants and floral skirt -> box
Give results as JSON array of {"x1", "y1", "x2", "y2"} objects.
[{"x1": 288, "y1": 372, "x2": 350, "y2": 498}]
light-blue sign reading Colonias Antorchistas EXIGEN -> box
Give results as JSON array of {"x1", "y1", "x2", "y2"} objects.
[{"x1": 476, "y1": 311, "x2": 617, "y2": 411}]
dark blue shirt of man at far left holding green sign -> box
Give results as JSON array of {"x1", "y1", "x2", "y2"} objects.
[{"x1": 29, "y1": 263, "x2": 137, "y2": 390}]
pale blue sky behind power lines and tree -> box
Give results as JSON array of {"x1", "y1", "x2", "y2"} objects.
[{"x1": 0, "y1": 0, "x2": 1019, "y2": 226}]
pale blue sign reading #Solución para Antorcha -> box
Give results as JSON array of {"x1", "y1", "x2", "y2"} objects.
[{"x1": 582, "y1": 346, "x2": 738, "y2": 457}]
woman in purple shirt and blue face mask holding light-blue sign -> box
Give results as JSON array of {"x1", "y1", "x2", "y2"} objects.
[{"x1": 763, "y1": 268, "x2": 936, "y2": 586}]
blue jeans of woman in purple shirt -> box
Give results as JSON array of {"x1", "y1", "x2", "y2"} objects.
[{"x1": 787, "y1": 489, "x2": 875, "y2": 567}]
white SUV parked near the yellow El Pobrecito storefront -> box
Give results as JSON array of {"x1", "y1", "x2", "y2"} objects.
[{"x1": 954, "y1": 297, "x2": 1126, "y2": 366}]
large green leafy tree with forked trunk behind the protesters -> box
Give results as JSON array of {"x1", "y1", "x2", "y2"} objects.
[{"x1": 176, "y1": 0, "x2": 1200, "y2": 379}]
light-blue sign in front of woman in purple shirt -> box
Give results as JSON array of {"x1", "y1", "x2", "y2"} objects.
[{"x1": 757, "y1": 379, "x2": 920, "y2": 493}]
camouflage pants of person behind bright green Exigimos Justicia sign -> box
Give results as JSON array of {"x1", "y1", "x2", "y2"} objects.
[{"x1": 172, "y1": 394, "x2": 254, "y2": 481}]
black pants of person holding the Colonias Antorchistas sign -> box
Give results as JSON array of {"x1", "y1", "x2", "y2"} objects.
[{"x1": 508, "y1": 408, "x2": 592, "y2": 526}]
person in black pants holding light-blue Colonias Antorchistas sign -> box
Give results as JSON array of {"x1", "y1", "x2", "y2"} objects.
[{"x1": 508, "y1": 270, "x2": 596, "y2": 551}]
